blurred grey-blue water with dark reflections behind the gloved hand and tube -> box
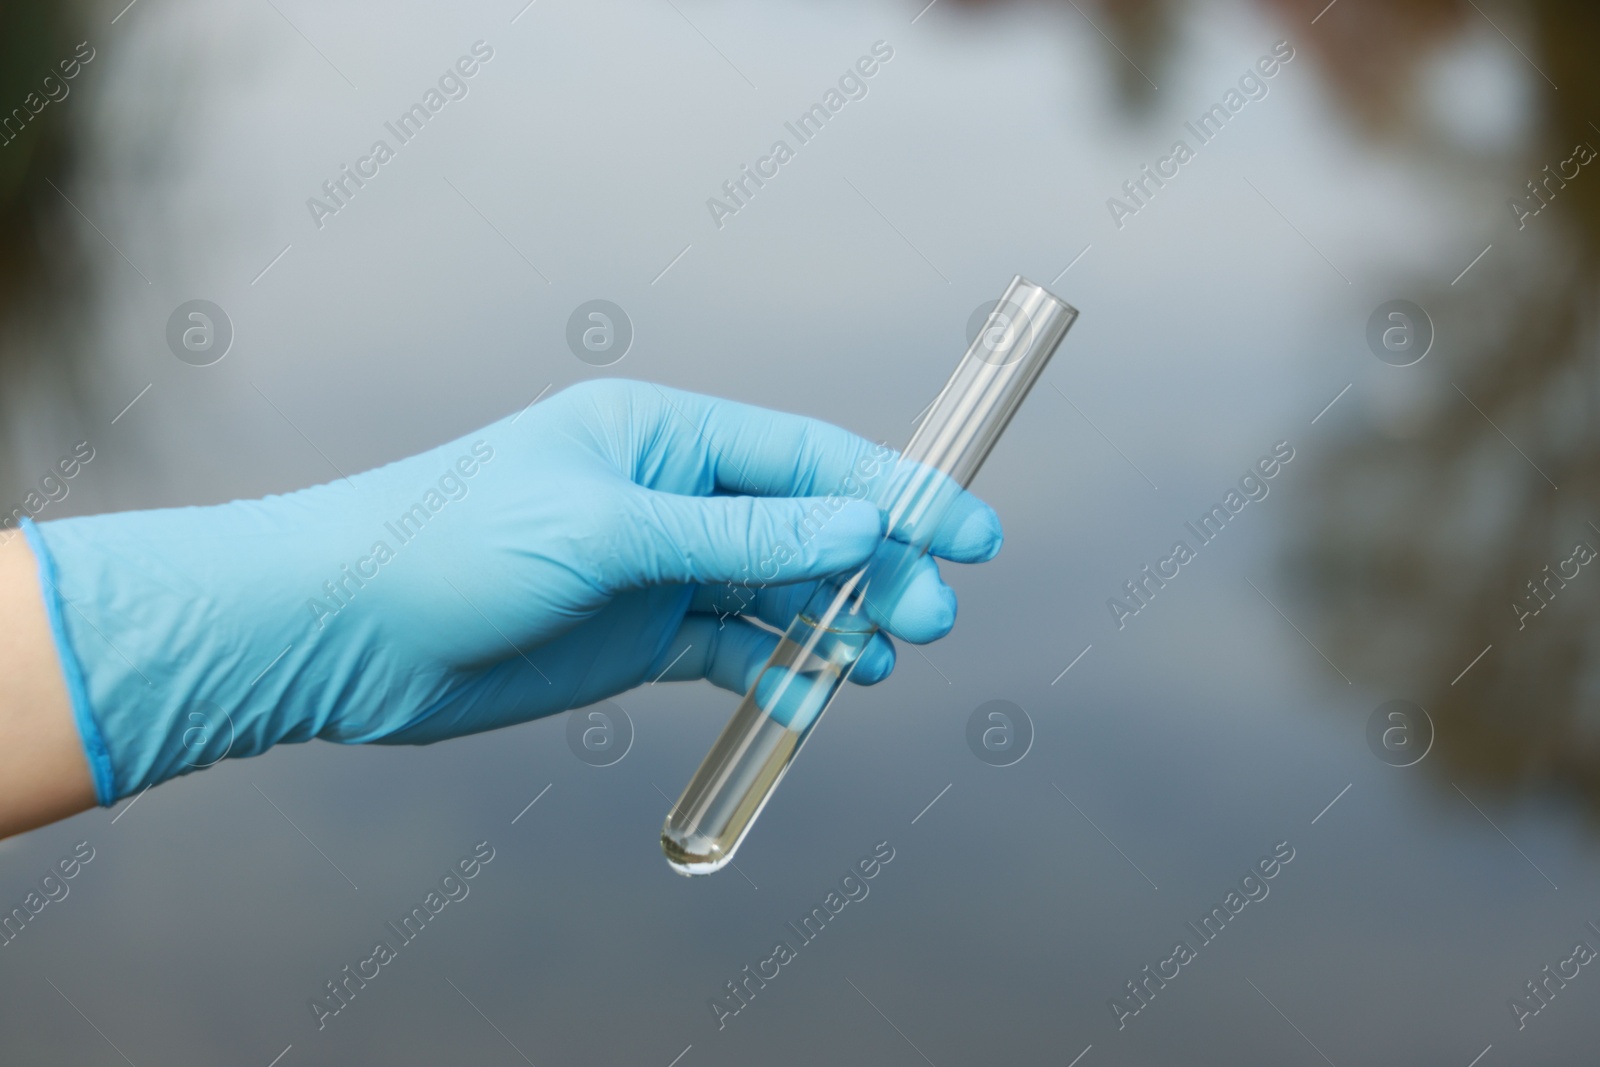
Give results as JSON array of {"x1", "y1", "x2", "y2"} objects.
[{"x1": 0, "y1": 0, "x2": 1600, "y2": 1067}]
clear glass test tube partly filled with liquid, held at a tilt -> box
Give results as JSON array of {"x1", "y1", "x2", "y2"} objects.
[{"x1": 661, "y1": 275, "x2": 1078, "y2": 875}]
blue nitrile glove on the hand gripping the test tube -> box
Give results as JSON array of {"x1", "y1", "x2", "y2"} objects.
[{"x1": 26, "y1": 381, "x2": 1000, "y2": 805}]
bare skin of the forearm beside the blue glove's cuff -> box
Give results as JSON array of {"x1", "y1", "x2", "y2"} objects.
[{"x1": 0, "y1": 533, "x2": 94, "y2": 837}]
